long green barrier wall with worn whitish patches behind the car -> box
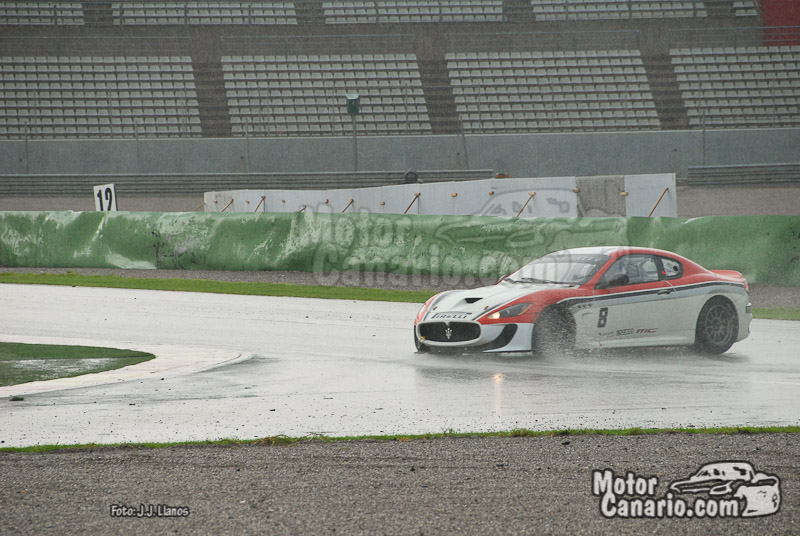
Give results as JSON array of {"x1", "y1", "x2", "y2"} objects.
[{"x1": 0, "y1": 212, "x2": 800, "y2": 286}]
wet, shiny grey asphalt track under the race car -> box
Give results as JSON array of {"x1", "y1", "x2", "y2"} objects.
[{"x1": 0, "y1": 285, "x2": 800, "y2": 447}]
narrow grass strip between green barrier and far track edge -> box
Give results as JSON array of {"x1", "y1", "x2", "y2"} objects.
[{"x1": 0, "y1": 272, "x2": 800, "y2": 321}]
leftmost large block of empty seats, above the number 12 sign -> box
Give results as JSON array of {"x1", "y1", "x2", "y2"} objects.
[{"x1": 0, "y1": 52, "x2": 200, "y2": 137}]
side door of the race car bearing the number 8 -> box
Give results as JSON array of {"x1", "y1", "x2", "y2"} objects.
[{"x1": 578, "y1": 253, "x2": 675, "y2": 348}]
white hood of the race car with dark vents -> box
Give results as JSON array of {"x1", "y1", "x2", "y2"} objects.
[{"x1": 423, "y1": 282, "x2": 569, "y2": 321}]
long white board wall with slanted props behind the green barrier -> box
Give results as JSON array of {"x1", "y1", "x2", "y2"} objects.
[{"x1": 204, "y1": 173, "x2": 678, "y2": 218}]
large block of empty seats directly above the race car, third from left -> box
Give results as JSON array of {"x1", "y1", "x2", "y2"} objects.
[{"x1": 446, "y1": 50, "x2": 658, "y2": 133}]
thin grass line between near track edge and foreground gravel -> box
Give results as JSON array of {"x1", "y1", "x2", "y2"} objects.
[{"x1": 0, "y1": 426, "x2": 800, "y2": 452}]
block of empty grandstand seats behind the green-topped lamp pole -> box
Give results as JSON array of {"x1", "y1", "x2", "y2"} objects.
[{"x1": 222, "y1": 54, "x2": 431, "y2": 136}]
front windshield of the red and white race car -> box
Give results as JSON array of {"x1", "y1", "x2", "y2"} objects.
[{"x1": 505, "y1": 252, "x2": 609, "y2": 285}]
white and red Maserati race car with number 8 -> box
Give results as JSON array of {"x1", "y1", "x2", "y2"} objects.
[{"x1": 414, "y1": 246, "x2": 753, "y2": 354}]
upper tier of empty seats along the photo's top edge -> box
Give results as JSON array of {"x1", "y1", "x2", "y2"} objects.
[{"x1": 0, "y1": 0, "x2": 761, "y2": 26}]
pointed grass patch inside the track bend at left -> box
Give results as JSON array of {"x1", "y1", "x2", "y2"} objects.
[{"x1": 0, "y1": 342, "x2": 155, "y2": 387}]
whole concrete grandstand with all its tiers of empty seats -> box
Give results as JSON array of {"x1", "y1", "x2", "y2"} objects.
[{"x1": 0, "y1": 0, "x2": 800, "y2": 198}]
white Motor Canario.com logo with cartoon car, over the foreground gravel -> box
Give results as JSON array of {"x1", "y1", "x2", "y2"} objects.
[{"x1": 592, "y1": 461, "x2": 781, "y2": 519}]
